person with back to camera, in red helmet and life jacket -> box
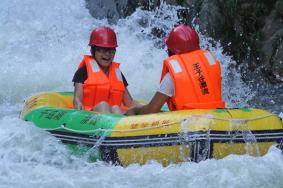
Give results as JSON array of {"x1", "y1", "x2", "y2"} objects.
[{"x1": 125, "y1": 25, "x2": 225, "y2": 115}]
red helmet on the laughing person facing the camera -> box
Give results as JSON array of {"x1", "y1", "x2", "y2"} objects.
[{"x1": 88, "y1": 27, "x2": 118, "y2": 48}]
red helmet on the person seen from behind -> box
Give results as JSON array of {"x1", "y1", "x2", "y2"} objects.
[{"x1": 165, "y1": 25, "x2": 200, "y2": 54}]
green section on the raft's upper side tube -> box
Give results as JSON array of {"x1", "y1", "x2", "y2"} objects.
[{"x1": 25, "y1": 107, "x2": 124, "y2": 136}]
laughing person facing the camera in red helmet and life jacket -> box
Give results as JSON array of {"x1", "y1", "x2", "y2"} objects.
[{"x1": 72, "y1": 27, "x2": 137, "y2": 114}]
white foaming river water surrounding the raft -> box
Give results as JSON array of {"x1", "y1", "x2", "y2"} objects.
[{"x1": 0, "y1": 0, "x2": 283, "y2": 188}]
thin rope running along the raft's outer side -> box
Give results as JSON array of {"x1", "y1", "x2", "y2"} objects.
[{"x1": 43, "y1": 114, "x2": 277, "y2": 133}]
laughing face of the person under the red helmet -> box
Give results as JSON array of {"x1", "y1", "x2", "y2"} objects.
[{"x1": 94, "y1": 47, "x2": 116, "y2": 68}]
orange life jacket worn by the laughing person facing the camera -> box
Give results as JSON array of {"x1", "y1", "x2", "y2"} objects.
[{"x1": 79, "y1": 55, "x2": 125, "y2": 110}]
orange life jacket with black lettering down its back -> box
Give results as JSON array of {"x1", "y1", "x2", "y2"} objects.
[{"x1": 161, "y1": 50, "x2": 225, "y2": 110}]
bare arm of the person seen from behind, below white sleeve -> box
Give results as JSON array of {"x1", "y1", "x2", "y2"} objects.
[{"x1": 125, "y1": 92, "x2": 169, "y2": 115}]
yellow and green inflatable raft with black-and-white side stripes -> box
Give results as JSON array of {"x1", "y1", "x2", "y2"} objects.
[{"x1": 21, "y1": 92, "x2": 283, "y2": 166}]
